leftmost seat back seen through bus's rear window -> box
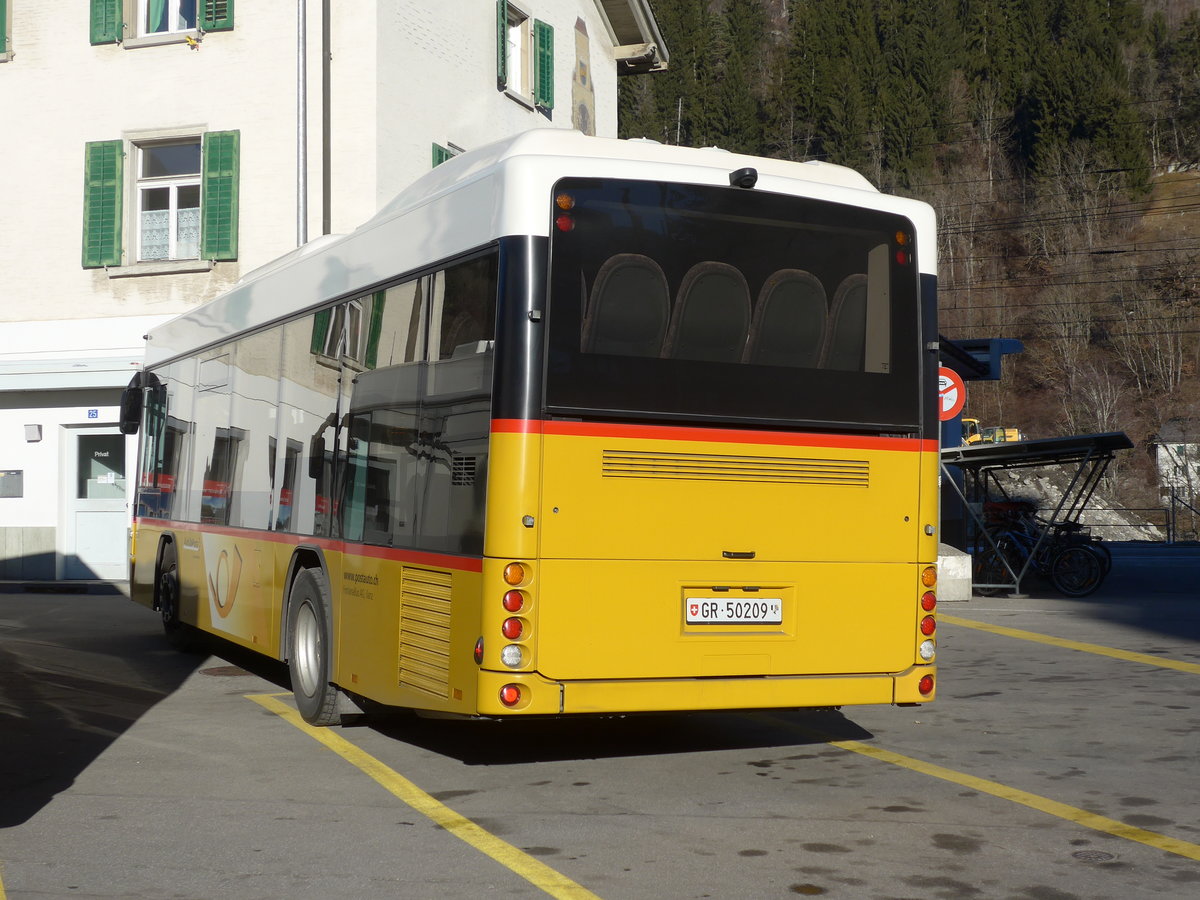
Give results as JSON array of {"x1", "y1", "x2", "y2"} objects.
[{"x1": 581, "y1": 253, "x2": 671, "y2": 356}]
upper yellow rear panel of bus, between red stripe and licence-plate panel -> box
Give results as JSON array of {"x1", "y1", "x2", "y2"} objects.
[{"x1": 540, "y1": 430, "x2": 937, "y2": 563}]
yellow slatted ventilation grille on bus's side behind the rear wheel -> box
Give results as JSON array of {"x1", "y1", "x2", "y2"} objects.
[{"x1": 400, "y1": 566, "x2": 451, "y2": 697}]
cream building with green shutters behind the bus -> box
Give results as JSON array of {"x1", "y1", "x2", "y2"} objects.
[{"x1": 0, "y1": 0, "x2": 667, "y2": 580}]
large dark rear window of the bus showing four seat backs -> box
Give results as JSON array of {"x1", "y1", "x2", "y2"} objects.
[{"x1": 546, "y1": 179, "x2": 919, "y2": 430}]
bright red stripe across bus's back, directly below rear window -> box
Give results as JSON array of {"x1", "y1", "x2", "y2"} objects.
[{"x1": 492, "y1": 419, "x2": 940, "y2": 454}]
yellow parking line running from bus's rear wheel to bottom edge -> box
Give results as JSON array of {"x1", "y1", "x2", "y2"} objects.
[{"x1": 246, "y1": 694, "x2": 599, "y2": 900}]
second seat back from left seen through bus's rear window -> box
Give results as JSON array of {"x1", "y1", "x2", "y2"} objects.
[{"x1": 664, "y1": 262, "x2": 750, "y2": 362}]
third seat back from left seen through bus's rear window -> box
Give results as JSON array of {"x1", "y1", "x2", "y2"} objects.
[{"x1": 742, "y1": 269, "x2": 829, "y2": 368}]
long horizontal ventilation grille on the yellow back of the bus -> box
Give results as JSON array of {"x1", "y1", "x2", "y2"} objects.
[{"x1": 601, "y1": 450, "x2": 871, "y2": 487}]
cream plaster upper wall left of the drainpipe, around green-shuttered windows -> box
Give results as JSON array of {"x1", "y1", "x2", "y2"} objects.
[{"x1": 0, "y1": 0, "x2": 319, "y2": 322}]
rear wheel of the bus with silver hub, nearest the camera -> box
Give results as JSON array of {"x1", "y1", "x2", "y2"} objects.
[{"x1": 288, "y1": 569, "x2": 341, "y2": 725}]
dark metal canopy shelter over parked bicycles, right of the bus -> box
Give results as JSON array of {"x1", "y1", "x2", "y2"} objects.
[{"x1": 942, "y1": 431, "x2": 1133, "y2": 592}]
